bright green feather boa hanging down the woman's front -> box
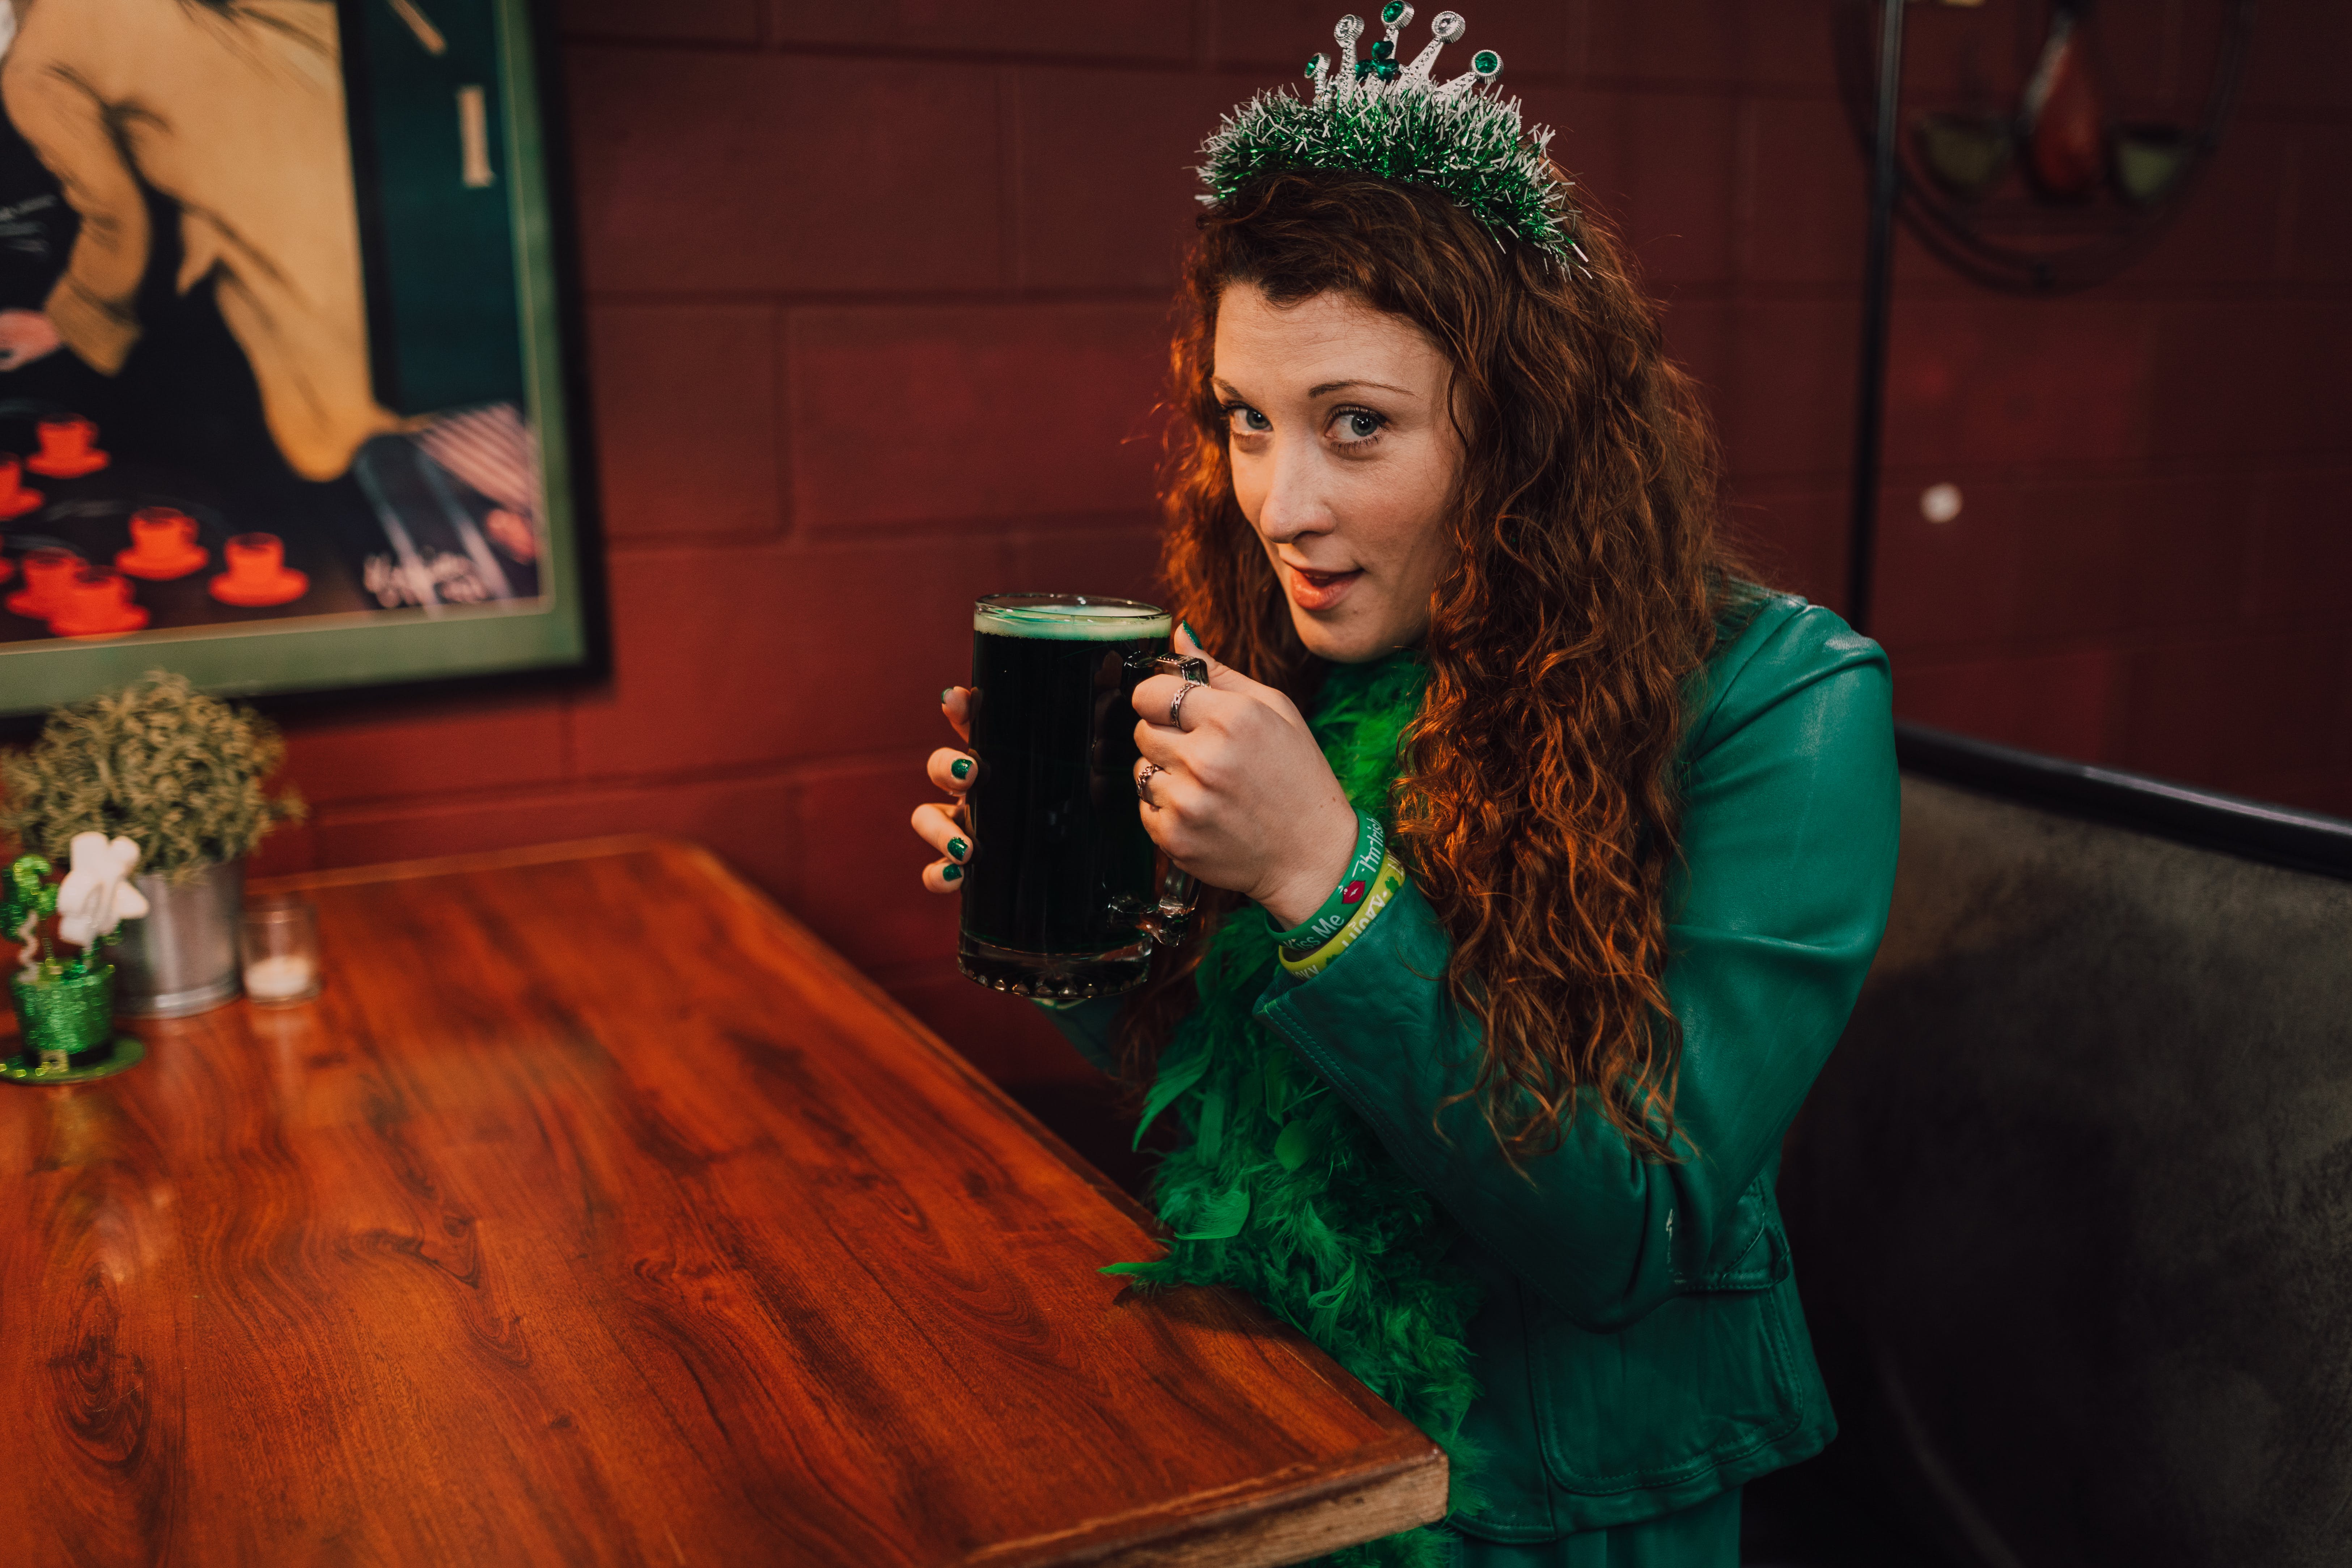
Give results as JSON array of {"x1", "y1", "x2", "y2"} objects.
[{"x1": 1105, "y1": 653, "x2": 1479, "y2": 1568}]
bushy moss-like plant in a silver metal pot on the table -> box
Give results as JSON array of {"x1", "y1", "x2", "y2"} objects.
[{"x1": 0, "y1": 672, "x2": 301, "y2": 1018}]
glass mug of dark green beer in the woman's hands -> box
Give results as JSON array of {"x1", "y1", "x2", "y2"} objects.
[{"x1": 957, "y1": 595, "x2": 1195, "y2": 997}]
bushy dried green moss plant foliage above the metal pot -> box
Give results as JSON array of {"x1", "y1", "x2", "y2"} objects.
[{"x1": 0, "y1": 672, "x2": 304, "y2": 882}]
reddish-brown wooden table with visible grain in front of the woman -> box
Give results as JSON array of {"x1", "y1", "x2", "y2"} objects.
[{"x1": 0, "y1": 839, "x2": 1446, "y2": 1568}]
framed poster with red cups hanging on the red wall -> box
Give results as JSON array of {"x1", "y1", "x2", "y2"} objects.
[{"x1": 0, "y1": 0, "x2": 597, "y2": 715}]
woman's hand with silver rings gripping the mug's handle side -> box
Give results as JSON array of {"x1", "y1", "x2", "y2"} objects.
[{"x1": 1136, "y1": 628, "x2": 1355, "y2": 926}]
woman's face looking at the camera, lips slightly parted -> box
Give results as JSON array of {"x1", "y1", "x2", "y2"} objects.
[{"x1": 1211, "y1": 282, "x2": 1461, "y2": 665}]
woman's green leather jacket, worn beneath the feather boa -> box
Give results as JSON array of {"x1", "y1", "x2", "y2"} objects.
[{"x1": 1054, "y1": 597, "x2": 1900, "y2": 1542}]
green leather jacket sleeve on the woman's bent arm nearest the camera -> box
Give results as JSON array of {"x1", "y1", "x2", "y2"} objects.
[{"x1": 1258, "y1": 609, "x2": 1900, "y2": 1331}]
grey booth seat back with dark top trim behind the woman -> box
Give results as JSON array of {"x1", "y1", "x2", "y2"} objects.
[{"x1": 1780, "y1": 731, "x2": 2352, "y2": 1568}]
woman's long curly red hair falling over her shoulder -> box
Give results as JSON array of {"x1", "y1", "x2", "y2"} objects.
[{"x1": 1122, "y1": 171, "x2": 1747, "y2": 1161}]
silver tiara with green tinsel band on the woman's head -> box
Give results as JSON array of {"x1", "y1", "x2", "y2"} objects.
[{"x1": 1200, "y1": 0, "x2": 1585, "y2": 263}]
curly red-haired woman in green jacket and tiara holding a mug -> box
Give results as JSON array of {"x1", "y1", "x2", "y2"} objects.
[{"x1": 917, "y1": 15, "x2": 1898, "y2": 1568}]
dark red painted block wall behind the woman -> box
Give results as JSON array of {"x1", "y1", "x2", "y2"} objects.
[{"x1": 271, "y1": 0, "x2": 2352, "y2": 1105}]
